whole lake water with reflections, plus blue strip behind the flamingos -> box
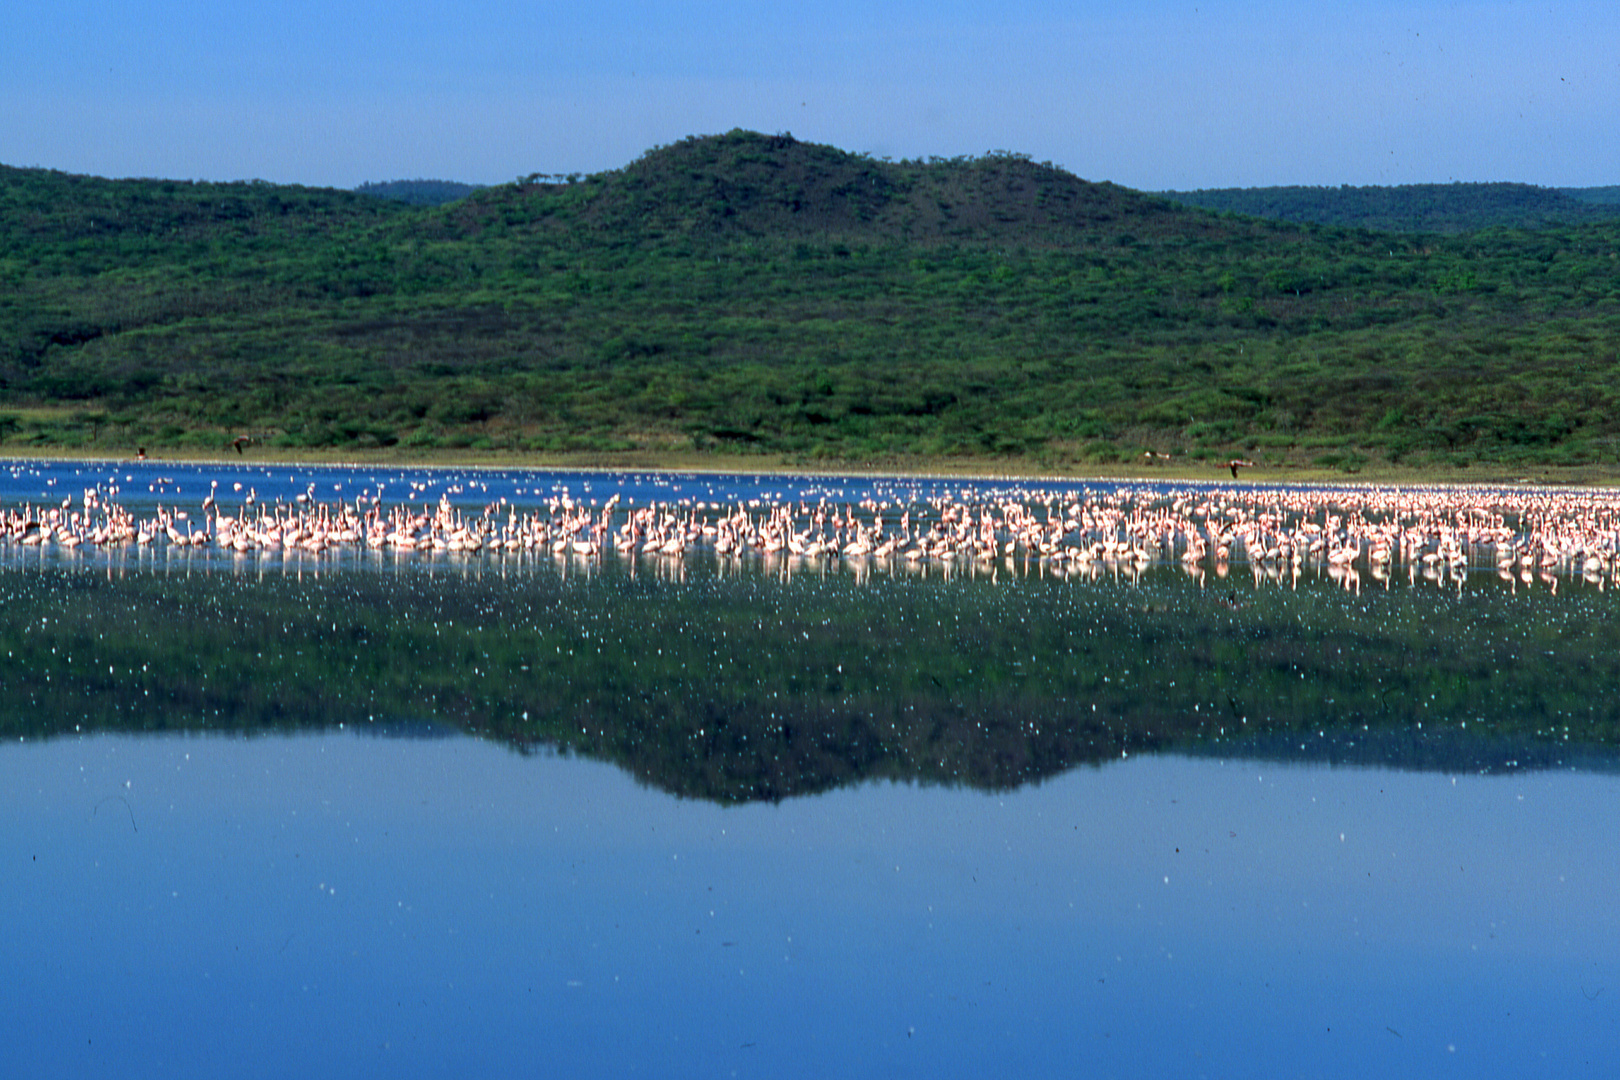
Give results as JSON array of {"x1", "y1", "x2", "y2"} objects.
[{"x1": 0, "y1": 463, "x2": 1620, "y2": 1077}]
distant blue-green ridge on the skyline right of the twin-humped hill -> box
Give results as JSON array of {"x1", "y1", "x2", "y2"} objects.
[{"x1": 1160, "y1": 183, "x2": 1620, "y2": 233}]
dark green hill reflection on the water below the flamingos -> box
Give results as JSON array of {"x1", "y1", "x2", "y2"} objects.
[{"x1": 0, "y1": 560, "x2": 1620, "y2": 801}]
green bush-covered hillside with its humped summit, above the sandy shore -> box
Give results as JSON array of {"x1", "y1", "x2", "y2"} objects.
[{"x1": 0, "y1": 131, "x2": 1620, "y2": 471}]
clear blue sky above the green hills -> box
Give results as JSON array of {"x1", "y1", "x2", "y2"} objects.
[{"x1": 0, "y1": 0, "x2": 1620, "y2": 189}]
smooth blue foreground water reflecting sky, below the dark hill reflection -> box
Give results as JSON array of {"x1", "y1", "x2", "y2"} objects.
[{"x1": 12, "y1": 733, "x2": 1620, "y2": 1077}]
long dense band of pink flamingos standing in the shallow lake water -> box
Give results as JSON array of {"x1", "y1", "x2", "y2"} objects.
[{"x1": 0, "y1": 481, "x2": 1620, "y2": 583}]
